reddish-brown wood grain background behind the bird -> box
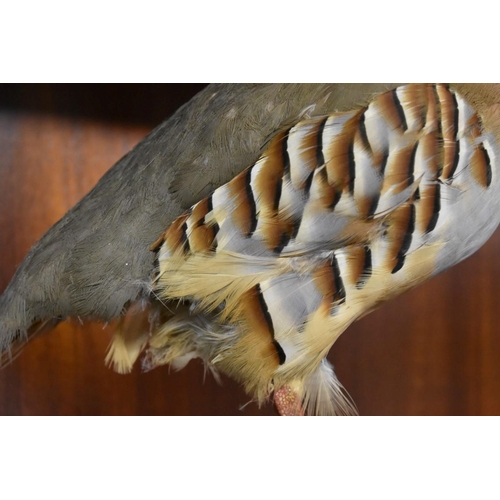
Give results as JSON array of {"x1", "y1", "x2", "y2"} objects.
[{"x1": 0, "y1": 85, "x2": 500, "y2": 415}]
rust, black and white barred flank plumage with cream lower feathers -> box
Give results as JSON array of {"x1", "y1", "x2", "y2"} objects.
[{"x1": 125, "y1": 84, "x2": 496, "y2": 414}]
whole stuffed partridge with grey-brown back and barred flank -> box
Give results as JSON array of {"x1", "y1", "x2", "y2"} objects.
[{"x1": 0, "y1": 84, "x2": 500, "y2": 415}]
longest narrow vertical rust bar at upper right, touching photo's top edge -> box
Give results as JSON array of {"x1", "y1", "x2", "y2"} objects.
[{"x1": 437, "y1": 85, "x2": 460, "y2": 180}]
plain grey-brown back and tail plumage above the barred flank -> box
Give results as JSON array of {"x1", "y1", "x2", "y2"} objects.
[{"x1": 0, "y1": 84, "x2": 398, "y2": 350}]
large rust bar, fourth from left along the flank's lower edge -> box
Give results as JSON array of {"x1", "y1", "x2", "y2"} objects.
[{"x1": 388, "y1": 203, "x2": 415, "y2": 274}]
